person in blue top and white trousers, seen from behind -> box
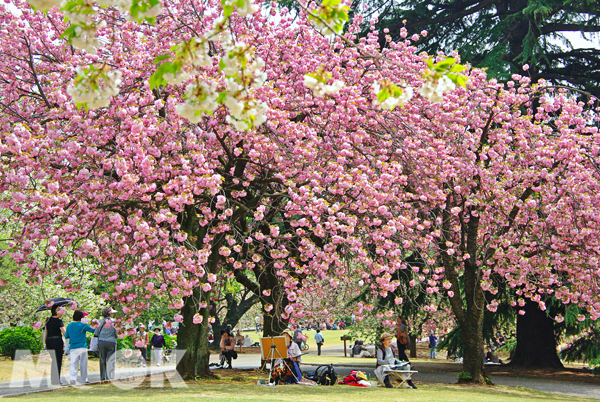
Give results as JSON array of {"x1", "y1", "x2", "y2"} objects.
[{"x1": 65, "y1": 310, "x2": 95, "y2": 385}]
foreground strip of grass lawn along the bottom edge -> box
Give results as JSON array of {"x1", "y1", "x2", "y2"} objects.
[{"x1": 16, "y1": 381, "x2": 584, "y2": 402}]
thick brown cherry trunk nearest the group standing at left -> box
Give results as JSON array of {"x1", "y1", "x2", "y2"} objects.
[{"x1": 177, "y1": 287, "x2": 212, "y2": 380}]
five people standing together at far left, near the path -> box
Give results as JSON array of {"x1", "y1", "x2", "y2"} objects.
[{"x1": 44, "y1": 305, "x2": 172, "y2": 385}]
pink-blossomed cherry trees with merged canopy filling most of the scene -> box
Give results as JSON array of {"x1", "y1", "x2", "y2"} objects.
[{"x1": 0, "y1": 0, "x2": 600, "y2": 382}]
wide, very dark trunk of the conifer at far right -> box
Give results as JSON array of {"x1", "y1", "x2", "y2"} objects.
[{"x1": 510, "y1": 299, "x2": 563, "y2": 368}]
